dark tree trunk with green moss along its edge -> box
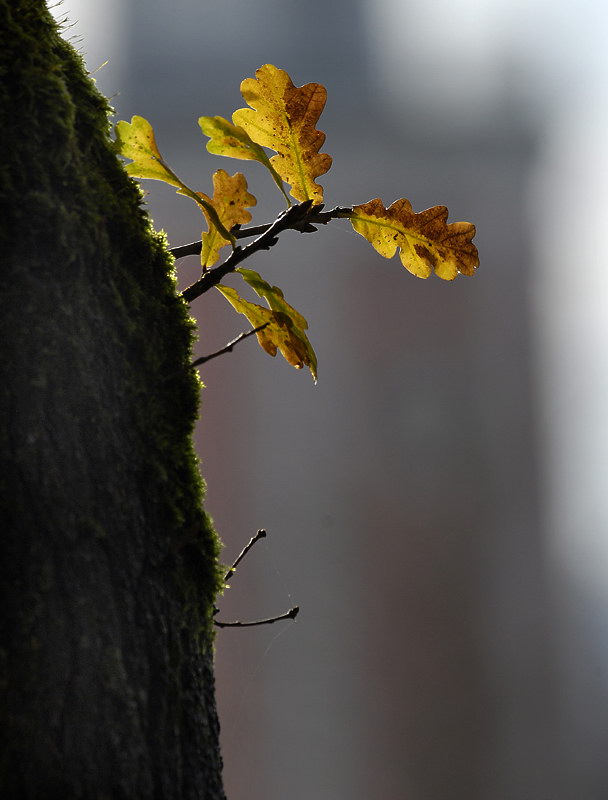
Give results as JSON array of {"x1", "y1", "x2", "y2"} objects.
[{"x1": 0, "y1": 0, "x2": 224, "y2": 800}]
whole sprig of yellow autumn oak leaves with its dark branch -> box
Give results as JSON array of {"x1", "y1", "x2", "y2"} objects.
[{"x1": 116, "y1": 64, "x2": 479, "y2": 380}]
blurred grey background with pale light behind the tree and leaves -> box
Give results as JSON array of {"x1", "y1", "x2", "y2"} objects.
[{"x1": 54, "y1": 0, "x2": 608, "y2": 800}]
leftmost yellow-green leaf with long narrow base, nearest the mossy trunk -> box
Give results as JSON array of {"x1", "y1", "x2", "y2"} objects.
[{"x1": 114, "y1": 116, "x2": 236, "y2": 244}]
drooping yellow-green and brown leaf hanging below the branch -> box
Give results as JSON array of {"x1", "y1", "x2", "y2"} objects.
[{"x1": 216, "y1": 280, "x2": 317, "y2": 383}]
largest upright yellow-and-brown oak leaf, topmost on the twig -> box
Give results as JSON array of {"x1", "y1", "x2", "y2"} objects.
[{"x1": 232, "y1": 64, "x2": 331, "y2": 203}]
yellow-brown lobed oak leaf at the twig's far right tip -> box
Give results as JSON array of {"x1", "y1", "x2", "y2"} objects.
[{"x1": 350, "y1": 198, "x2": 479, "y2": 281}]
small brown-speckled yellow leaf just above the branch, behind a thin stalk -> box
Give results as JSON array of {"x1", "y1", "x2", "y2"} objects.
[{"x1": 199, "y1": 169, "x2": 257, "y2": 267}]
